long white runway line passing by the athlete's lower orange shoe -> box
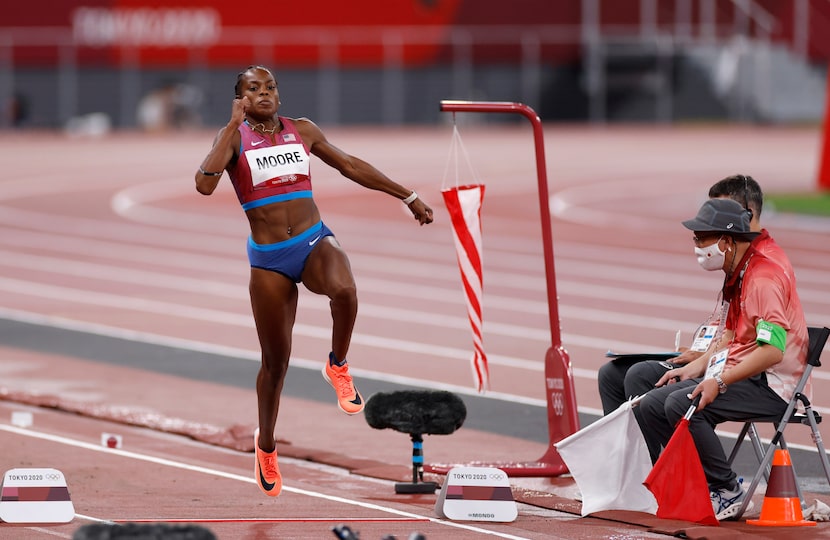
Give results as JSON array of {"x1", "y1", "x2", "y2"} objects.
[{"x1": 0, "y1": 424, "x2": 525, "y2": 540}]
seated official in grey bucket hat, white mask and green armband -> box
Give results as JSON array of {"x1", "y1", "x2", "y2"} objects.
[{"x1": 634, "y1": 199, "x2": 809, "y2": 520}]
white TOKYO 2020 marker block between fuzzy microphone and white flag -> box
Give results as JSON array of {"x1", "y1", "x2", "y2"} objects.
[{"x1": 435, "y1": 467, "x2": 519, "y2": 522}]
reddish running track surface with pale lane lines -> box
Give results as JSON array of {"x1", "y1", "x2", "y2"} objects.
[{"x1": 0, "y1": 124, "x2": 830, "y2": 540}]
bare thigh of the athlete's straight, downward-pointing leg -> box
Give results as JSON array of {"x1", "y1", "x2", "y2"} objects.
[{"x1": 249, "y1": 268, "x2": 297, "y2": 358}]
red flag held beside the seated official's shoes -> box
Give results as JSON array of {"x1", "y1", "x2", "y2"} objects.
[{"x1": 643, "y1": 418, "x2": 719, "y2": 525}]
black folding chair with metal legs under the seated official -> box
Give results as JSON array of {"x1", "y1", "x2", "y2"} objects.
[{"x1": 729, "y1": 327, "x2": 830, "y2": 519}]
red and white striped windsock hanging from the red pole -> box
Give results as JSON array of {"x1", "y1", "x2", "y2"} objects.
[{"x1": 441, "y1": 184, "x2": 490, "y2": 392}]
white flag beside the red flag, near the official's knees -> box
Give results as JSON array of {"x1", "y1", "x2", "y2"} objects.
[{"x1": 554, "y1": 401, "x2": 657, "y2": 516}]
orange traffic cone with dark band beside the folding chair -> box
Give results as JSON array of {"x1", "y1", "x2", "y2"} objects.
[{"x1": 746, "y1": 449, "x2": 816, "y2": 527}]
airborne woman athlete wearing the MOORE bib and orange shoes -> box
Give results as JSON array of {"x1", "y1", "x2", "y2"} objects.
[{"x1": 195, "y1": 66, "x2": 433, "y2": 496}]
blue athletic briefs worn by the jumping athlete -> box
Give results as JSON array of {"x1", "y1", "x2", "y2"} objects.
[{"x1": 248, "y1": 221, "x2": 334, "y2": 283}]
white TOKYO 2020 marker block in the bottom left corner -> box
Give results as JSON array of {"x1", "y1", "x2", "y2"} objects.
[{"x1": 0, "y1": 469, "x2": 75, "y2": 523}]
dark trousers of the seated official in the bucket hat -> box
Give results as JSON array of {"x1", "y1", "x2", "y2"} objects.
[{"x1": 634, "y1": 374, "x2": 787, "y2": 491}]
